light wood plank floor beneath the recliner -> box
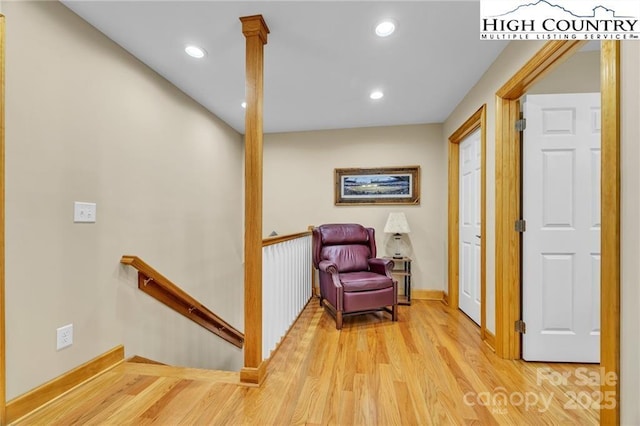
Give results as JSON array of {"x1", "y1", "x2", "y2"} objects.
[{"x1": 17, "y1": 299, "x2": 598, "y2": 425}]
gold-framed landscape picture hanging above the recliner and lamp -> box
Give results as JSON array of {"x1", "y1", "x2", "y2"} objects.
[{"x1": 335, "y1": 166, "x2": 420, "y2": 205}]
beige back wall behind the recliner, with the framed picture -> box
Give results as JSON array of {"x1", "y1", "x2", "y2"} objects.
[{"x1": 264, "y1": 125, "x2": 447, "y2": 290}]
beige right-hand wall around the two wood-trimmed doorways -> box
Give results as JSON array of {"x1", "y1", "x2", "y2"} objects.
[{"x1": 444, "y1": 41, "x2": 640, "y2": 425}]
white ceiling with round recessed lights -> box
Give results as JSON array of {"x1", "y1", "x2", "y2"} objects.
[{"x1": 62, "y1": 0, "x2": 506, "y2": 133}]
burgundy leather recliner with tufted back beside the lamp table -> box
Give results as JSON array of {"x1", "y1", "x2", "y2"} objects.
[{"x1": 313, "y1": 223, "x2": 398, "y2": 330}]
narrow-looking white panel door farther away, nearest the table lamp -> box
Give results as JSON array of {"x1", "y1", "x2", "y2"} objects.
[{"x1": 458, "y1": 129, "x2": 481, "y2": 324}]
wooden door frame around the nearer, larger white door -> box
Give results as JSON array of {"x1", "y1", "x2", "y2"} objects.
[{"x1": 495, "y1": 40, "x2": 620, "y2": 424}]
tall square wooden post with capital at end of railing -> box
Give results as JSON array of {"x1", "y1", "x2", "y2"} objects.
[{"x1": 240, "y1": 15, "x2": 269, "y2": 384}]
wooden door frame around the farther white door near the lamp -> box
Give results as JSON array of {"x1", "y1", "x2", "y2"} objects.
[{"x1": 446, "y1": 104, "x2": 487, "y2": 340}]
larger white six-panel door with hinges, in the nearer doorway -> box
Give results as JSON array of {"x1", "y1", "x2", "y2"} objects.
[{"x1": 522, "y1": 93, "x2": 600, "y2": 362}]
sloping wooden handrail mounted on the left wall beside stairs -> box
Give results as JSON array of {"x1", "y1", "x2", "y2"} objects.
[{"x1": 120, "y1": 255, "x2": 244, "y2": 348}]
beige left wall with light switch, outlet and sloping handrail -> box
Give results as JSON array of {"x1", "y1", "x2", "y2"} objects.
[{"x1": 3, "y1": 2, "x2": 243, "y2": 399}]
